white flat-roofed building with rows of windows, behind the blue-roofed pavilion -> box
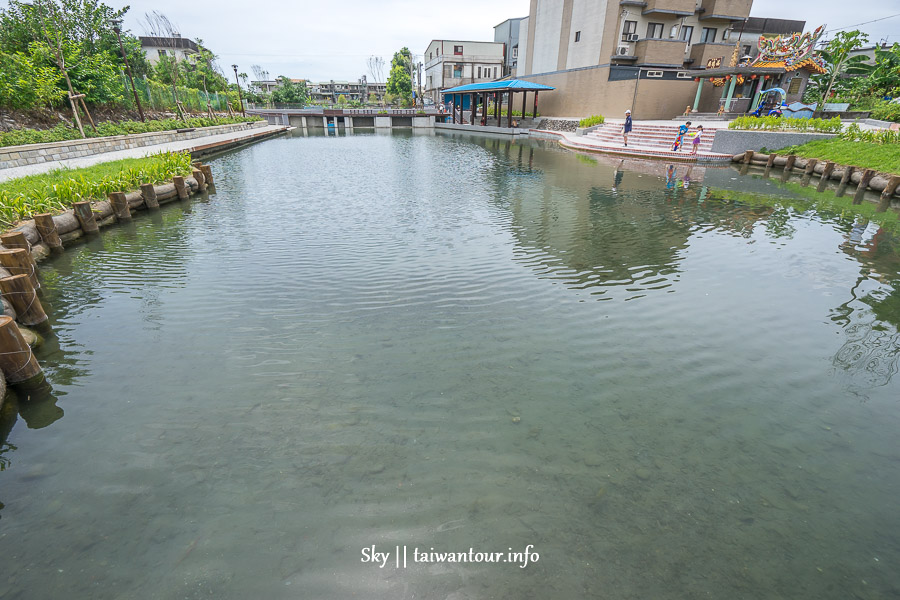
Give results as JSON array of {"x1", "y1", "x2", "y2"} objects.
[{"x1": 423, "y1": 40, "x2": 506, "y2": 103}]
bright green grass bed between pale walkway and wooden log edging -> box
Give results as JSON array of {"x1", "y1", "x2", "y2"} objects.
[{"x1": 0, "y1": 152, "x2": 191, "y2": 229}]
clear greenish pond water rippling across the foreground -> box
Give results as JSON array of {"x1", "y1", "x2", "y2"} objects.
[{"x1": 0, "y1": 135, "x2": 900, "y2": 600}]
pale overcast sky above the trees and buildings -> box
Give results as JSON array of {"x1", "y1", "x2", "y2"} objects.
[{"x1": 112, "y1": 0, "x2": 900, "y2": 81}]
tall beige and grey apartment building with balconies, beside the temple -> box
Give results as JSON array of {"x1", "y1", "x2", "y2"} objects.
[{"x1": 516, "y1": 0, "x2": 752, "y2": 119}]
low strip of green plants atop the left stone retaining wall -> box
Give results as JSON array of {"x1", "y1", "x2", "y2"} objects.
[{"x1": 0, "y1": 117, "x2": 262, "y2": 147}]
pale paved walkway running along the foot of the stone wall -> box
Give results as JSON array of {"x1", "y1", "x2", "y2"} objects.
[{"x1": 0, "y1": 125, "x2": 287, "y2": 181}]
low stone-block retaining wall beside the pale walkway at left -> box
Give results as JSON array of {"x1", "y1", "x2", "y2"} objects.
[{"x1": 0, "y1": 121, "x2": 267, "y2": 169}]
